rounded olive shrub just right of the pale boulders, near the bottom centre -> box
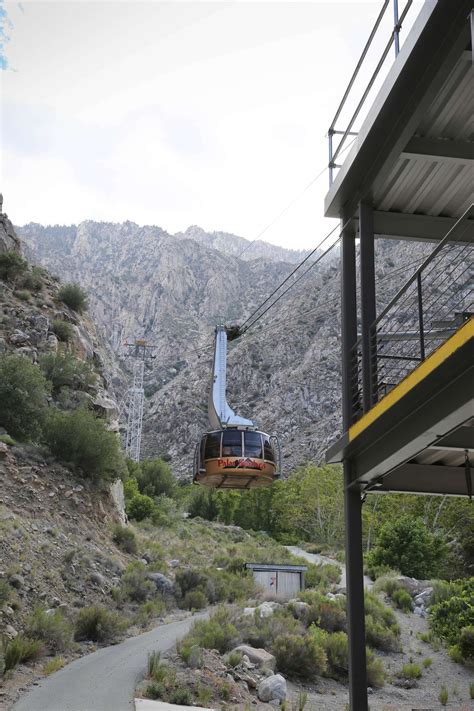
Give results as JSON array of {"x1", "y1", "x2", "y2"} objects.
[{"x1": 272, "y1": 634, "x2": 327, "y2": 679}]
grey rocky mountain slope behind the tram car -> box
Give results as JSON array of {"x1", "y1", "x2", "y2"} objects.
[{"x1": 19, "y1": 222, "x2": 430, "y2": 476}]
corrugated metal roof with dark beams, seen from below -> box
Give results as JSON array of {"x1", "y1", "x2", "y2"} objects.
[{"x1": 325, "y1": 0, "x2": 474, "y2": 239}]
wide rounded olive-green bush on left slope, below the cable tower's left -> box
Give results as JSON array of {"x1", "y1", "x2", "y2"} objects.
[{"x1": 44, "y1": 410, "x2": 123, "y2": 479}]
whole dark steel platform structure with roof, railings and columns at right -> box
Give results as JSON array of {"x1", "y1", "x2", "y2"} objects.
[{"x1": 325, "y1": 0, "x2": 474, "y2": 711}]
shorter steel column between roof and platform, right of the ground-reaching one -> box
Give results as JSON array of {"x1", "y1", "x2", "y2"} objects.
[{"x1": 359, "y1": 203, "x2": 376, "y2": 412}]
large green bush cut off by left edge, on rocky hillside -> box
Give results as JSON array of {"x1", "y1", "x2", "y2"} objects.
[{"x1": 0, "y1": 355, "x2": 49, "y2": 439}]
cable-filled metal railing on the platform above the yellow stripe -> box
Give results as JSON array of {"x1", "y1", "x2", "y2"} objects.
[{"x1": 351, "y1": 205, "x2": 474, "y2": 422}]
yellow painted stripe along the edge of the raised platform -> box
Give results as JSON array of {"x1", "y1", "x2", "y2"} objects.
[{"x1": 348, "y1": 318, "x2": 474, "y2": 442}]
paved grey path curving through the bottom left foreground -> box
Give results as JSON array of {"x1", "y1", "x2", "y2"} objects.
[{"x1": 12, "y1": 613, "x2": 206, "y2": 711}]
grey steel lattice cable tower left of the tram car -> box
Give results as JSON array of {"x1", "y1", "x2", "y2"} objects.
[{"x1": 124, "y1": 338, "x2": 155, "y2": 462}]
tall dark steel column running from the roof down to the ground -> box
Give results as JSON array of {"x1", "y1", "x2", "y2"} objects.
[{"x1": 341, "y1": 216, "x2": 368, "y2": 711}]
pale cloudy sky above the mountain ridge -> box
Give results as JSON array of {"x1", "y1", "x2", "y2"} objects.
[{"x1": 0, "y1": 0, "x2": 421, "y2": 249}]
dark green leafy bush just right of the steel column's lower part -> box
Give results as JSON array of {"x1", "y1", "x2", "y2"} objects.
[{"x1": 368, "y1": 514, "x2": 446, "y2": 579}]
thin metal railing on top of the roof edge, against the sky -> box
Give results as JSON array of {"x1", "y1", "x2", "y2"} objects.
[{"x1": 328, "y1": 0, "x2": 413, "y2": 186}]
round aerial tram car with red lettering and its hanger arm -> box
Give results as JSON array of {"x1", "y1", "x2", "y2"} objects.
[{"x1": 193, "y1": 325, "x2": 281, "y2": 489}]
